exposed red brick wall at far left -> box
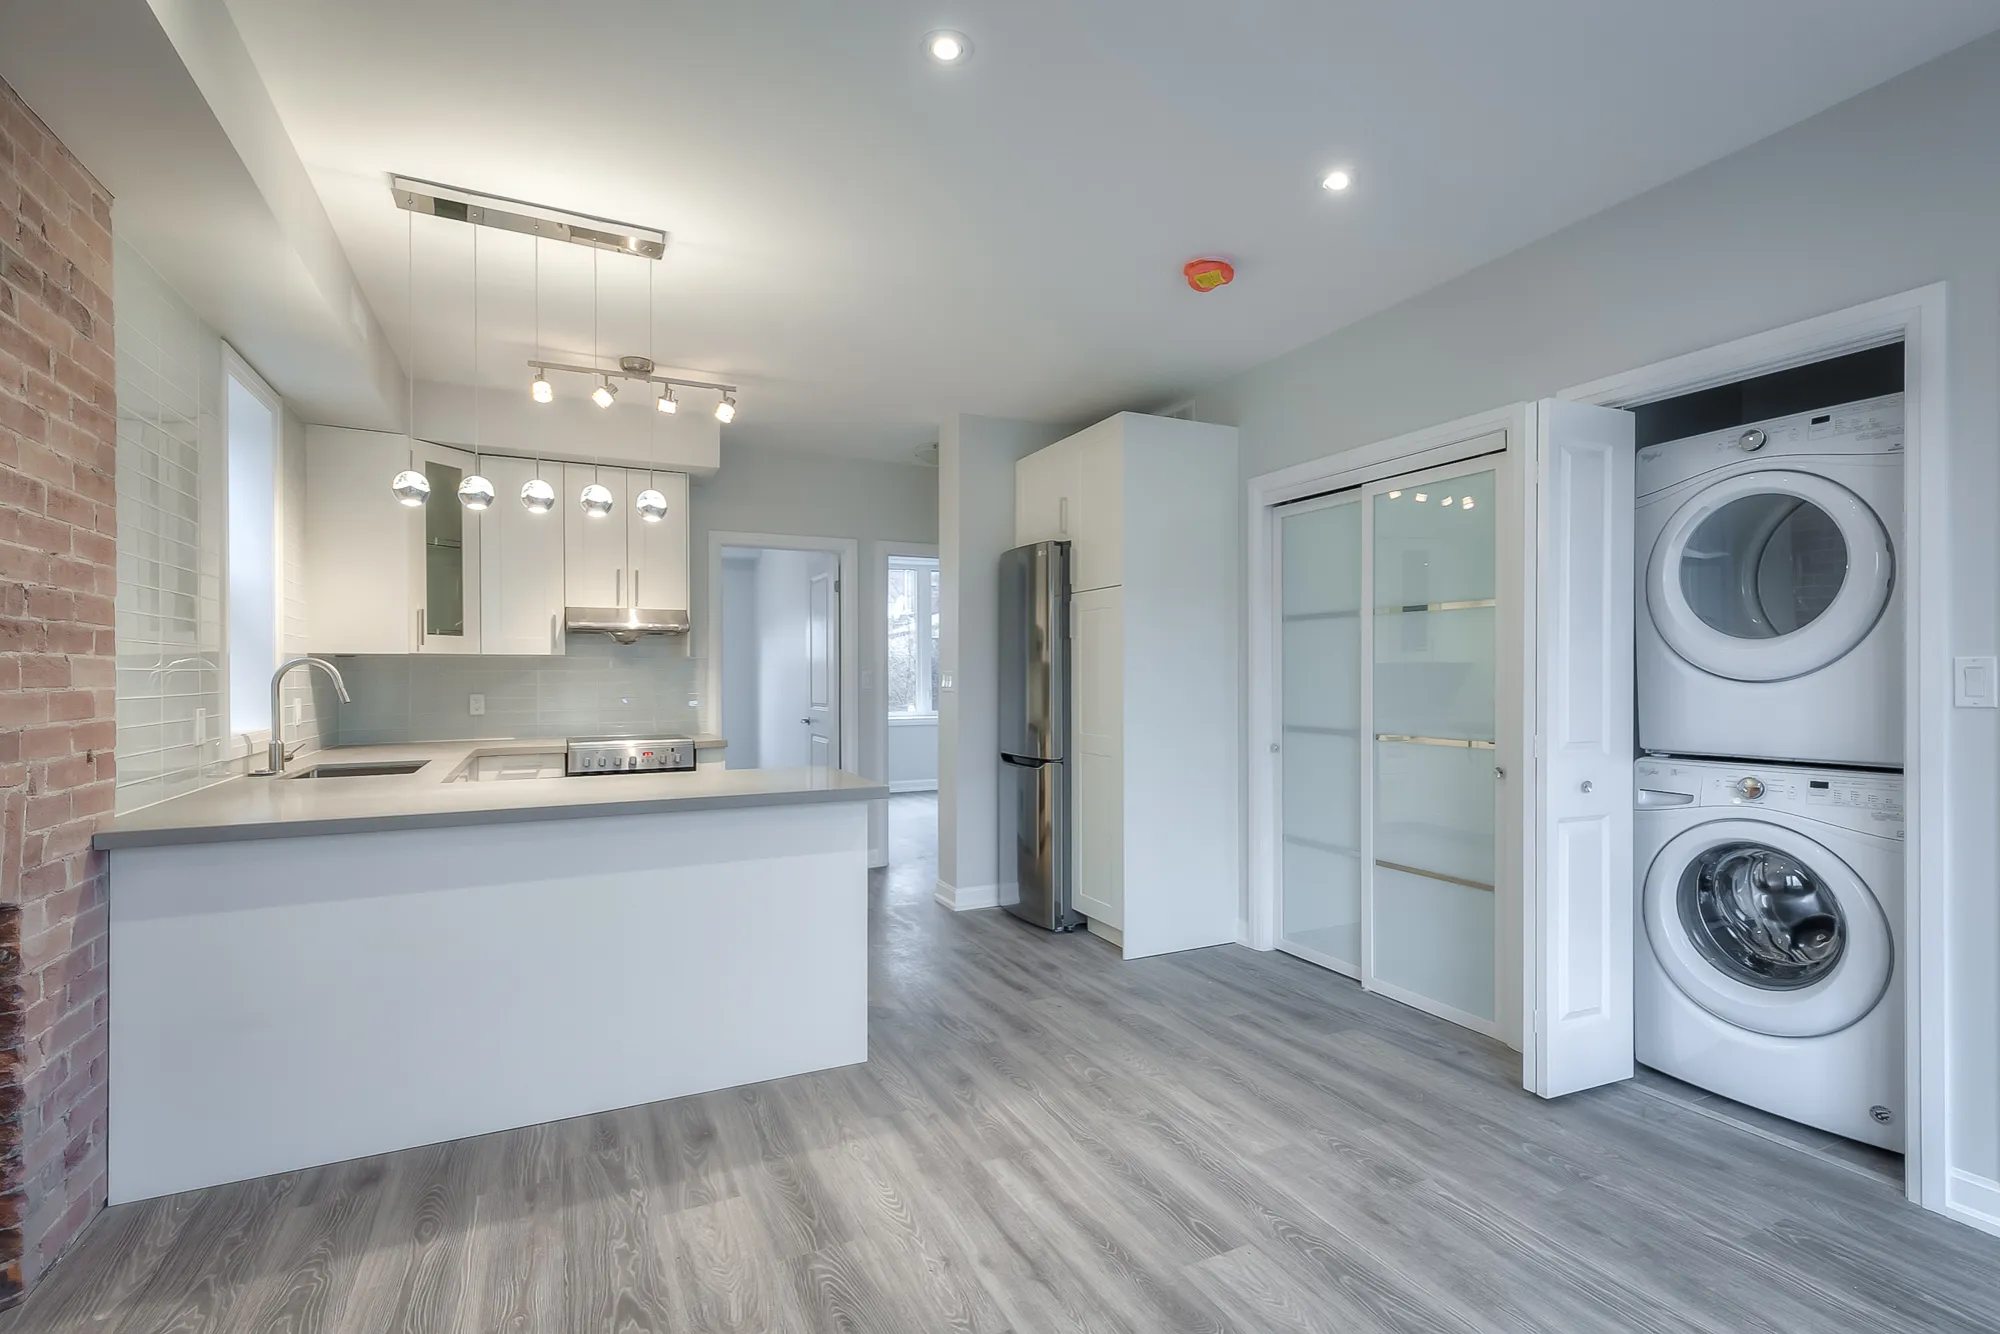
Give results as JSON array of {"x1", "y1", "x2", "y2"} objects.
[{"x1": 0, "y1": 82, "x2": 118, "y2": 1304}]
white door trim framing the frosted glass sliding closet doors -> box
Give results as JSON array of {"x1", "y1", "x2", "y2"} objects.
[{"x1": 1236, "y1": 406, "x2": 1534, "y2": 992}]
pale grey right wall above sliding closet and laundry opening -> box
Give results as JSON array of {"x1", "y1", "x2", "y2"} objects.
[{"x1": 1194, "y1": 38, "x2": 2000, "y2": 1204}]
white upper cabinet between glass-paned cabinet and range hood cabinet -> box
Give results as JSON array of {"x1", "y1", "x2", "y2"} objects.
[{"x1": 476, "y1": 456, "x2": 564, "y2": 656}]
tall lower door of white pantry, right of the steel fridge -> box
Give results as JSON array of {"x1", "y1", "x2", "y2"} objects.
[{"x1": 1070, "y1": 588, "x2": 1124, "y2": 930}]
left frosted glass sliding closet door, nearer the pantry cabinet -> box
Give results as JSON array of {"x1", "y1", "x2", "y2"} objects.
[{"x1": 1278, "y1": 492, "x2": 1366, "y2": 976}]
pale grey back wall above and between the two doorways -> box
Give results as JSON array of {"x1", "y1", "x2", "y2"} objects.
[{"x1": 688, "y1": 444, "x2": 940, "y2": 850}]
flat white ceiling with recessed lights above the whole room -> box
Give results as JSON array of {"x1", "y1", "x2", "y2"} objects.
[{"x1": 219, "y1": 0, "x2": 2000, "y2": 460}]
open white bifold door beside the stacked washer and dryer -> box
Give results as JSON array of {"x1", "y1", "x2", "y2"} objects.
[{"x1": 1522, "y1": 400, "x2": 1634, "y2": 1098}]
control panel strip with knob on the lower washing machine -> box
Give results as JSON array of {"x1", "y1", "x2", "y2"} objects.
[{"x1": 1634, "y1": 758, "x2": 1902, "y2": 838}]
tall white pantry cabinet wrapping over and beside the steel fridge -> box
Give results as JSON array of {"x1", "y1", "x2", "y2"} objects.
[{"x1": 1014, "y1": 412, "x2": 1242, "y2": 958}]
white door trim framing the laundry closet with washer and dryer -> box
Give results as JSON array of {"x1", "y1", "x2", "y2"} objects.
[{"x1": 1560, "y1": 282, "x2": 1952, "y2": 1234}]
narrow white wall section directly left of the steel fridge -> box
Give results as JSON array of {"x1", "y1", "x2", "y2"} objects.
[{"x1": 940, "y1": 416, "x2": 1070, "y2": 902}]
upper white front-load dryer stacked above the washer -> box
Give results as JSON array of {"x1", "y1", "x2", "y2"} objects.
[{"x1": 1634, "y1": 394, "x2": 1902, "y2": 768}]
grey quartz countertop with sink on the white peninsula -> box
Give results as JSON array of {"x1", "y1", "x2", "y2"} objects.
[{"x1": 92, "y1": 738, "x2": 888, "y2": 850}]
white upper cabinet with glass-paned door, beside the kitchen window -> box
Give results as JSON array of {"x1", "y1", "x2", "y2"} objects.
[{"x1": 306, "y1": 426, "x2": 480, "y2": 654}]
